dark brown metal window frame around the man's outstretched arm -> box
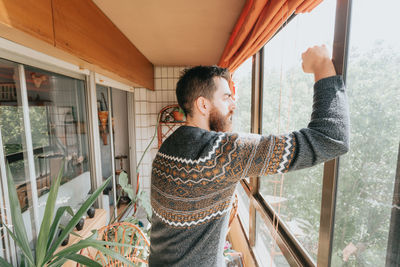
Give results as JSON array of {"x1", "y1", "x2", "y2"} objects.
[{"x1": 241, "y1": 0, "x2": 351, "y2": 266}]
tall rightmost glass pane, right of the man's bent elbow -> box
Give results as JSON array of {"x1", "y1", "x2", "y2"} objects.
[{"x1": 332, "y1": 0, "x2": 400, "y2": 266}]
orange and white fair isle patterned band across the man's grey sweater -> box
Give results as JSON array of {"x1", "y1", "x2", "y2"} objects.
[{"x1": 151, "y1": 132, "x2": 296, "y2": 228}]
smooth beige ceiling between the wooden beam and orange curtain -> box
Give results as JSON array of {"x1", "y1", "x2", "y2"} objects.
[{"x1": 93, "y1": 0, "x2": 246, "y2": 66}]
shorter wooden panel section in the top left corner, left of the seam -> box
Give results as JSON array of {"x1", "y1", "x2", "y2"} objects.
[{"x1": 0, "y1": 0, "x2": 54, "y2": 45}]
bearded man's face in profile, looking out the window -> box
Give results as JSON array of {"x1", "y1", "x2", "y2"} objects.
[{"x1": 209, "y1": 77, "x2": 236, "y2": 132}]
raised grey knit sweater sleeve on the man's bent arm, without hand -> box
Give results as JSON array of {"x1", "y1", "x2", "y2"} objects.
[{"x1": 227, "y1": 76, "x2": 349, "y2": 178}]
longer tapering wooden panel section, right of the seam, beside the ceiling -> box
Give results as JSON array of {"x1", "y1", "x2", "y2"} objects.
[{"x1": 53, "y1": 0, "x2": 154, "y2": 90}]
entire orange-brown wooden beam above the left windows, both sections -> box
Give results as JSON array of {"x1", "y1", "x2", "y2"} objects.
[{"x1": 0, "y1": 0, "x2": 154, "y2": 89}]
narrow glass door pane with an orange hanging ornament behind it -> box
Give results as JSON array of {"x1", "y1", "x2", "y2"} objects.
[{"x1": 96, "y1": 85, "x2": 116, "y2": 221}]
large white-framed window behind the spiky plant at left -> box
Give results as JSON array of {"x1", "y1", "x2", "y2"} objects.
[{"x1": 0, "y1": 60, "x2": 91, "y2": 247}]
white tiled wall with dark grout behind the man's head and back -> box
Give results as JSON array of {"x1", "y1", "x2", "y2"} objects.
[{"x1": 135, "y1": 66, "x2": 185, "y2": 193}]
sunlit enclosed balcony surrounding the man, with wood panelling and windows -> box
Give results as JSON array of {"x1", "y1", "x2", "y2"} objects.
[{"x1": 0, "y1": 0, "x2": 400, "y2": 266}]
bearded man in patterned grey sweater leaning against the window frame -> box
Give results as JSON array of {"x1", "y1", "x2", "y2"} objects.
[{"x1": 149, "y1": 46, "x2": 349, "y2": 266}]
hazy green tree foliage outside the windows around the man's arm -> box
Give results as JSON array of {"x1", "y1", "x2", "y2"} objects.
[{"x1": 248, "y1": 42, "x2": 400, "y2": 266}]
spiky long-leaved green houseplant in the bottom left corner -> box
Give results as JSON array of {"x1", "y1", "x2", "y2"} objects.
[{"x1": 0, "y1": 164, "x2": 133, "y2": 267}]
